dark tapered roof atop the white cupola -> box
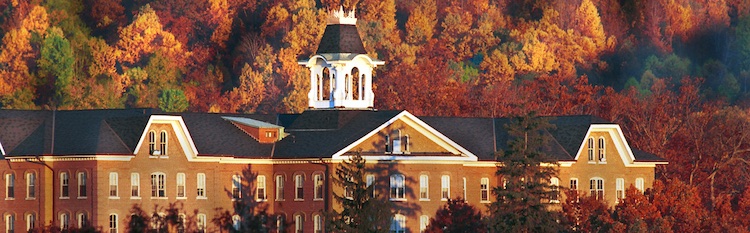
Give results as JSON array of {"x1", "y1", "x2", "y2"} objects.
[{"x1": 316, "y1": 24, "x2": 367, "y2": 54}]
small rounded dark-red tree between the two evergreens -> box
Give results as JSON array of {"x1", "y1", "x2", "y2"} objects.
[{"x1": 424, "y1": 197, "x2": 487, "y2": 233}]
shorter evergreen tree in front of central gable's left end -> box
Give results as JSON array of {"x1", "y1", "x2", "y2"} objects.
[{"x1": 326, "y1": 152, "x2": 393, "y2": 233}]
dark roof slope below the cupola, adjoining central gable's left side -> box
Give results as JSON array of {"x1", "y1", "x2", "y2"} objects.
[{"x1": 274, "y1": 110, "x2": 401, "y2": 158}]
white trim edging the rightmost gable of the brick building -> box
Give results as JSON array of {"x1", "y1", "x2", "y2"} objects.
[{"x1": 572, "y1": 124, "x2": 669, "y2": 167}]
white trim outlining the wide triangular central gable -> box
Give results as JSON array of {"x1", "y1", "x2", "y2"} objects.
[{"x1": 331, "y1": 111, "x2": 478, "y2": 161}]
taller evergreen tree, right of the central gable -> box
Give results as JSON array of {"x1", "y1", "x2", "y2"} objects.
[{"x1": 487, "y1": 112, "x2": 563, "y2": 232}]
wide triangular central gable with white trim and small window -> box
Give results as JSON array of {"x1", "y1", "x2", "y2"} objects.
[{"x1": 332, "y1": 111, "x2": 477, "y2": 161}]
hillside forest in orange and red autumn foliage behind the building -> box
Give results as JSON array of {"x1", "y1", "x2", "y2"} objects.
[{"x1": 0, "y1": 0, "x2": 750, "y2": 231}]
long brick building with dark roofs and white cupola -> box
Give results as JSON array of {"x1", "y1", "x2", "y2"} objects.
[{"x1": 0, "y1": 6, "x2": 666, "y2": 232}]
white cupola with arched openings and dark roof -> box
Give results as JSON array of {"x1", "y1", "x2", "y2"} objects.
[{"x1": 299, "y1": 7, "x2": 385, "y2": 109}]
